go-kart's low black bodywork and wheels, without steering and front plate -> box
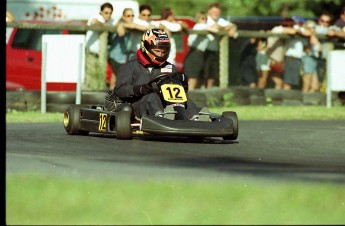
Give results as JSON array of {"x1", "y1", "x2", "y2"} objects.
[{"x1": 63, "y1": 103, "x2": 238, "y2": 140}]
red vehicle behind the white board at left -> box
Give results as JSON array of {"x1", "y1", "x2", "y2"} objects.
[{"x1": 6, "y1": 21, "x2": 112, "y2": 91}]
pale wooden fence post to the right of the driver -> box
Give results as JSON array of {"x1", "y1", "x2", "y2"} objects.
[{"x1": 219, "y1": 35, "x2": 229, "y2": 89}]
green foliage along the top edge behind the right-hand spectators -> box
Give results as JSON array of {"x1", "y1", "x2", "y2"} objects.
[{"x1": 138, "y1": 0, "x2": 344, "y2": 17}]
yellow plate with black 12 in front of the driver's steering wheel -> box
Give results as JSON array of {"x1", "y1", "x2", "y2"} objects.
[{"x1": 161, "y1": 84, "x2": 187, "y2": 103}]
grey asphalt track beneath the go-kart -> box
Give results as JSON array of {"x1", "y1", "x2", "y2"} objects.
[{"x1": 6, "y1": 120, "x2": 345, "y2": 183}]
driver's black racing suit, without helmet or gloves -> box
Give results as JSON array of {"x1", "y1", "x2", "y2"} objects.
[{"x1": 114, "y1": 50, "x2": 199, "y2": 118}]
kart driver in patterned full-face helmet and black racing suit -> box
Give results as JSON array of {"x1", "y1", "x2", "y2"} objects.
[{"x1": 109, "y1": 28, "x2": 203, "y2": 120}]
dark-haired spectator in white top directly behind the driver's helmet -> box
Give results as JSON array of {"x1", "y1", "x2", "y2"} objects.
[{"x1": 129, "y1": 4, "x2": 156, "y2": 59}]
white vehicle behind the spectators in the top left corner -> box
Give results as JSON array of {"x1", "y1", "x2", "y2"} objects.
[{"x1": 7, "y1": 0, "x2": 139, "y2": 21}]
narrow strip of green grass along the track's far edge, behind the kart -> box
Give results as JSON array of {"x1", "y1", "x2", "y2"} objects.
[{"x1": 6, "y1": 106, "x2": 345, "y2": 123}]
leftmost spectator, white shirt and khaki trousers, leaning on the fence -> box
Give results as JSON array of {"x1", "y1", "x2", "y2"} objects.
[{"x1": 83, "y1": 2, "x2": 115, "y2": 90}]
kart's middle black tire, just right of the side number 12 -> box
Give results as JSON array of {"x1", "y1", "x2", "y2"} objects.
[{"x1": 115, "y1": 111, "x2": 132, "y2": 140}]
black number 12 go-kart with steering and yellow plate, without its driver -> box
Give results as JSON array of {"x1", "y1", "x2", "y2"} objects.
[{"x1": 63, "y1": 74, "x2": 238, "y2": 140}]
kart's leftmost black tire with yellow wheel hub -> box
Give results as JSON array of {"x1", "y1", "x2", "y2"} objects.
[{"x1": 63, "y1": 104, "x2": 89, "y2": 136}]
